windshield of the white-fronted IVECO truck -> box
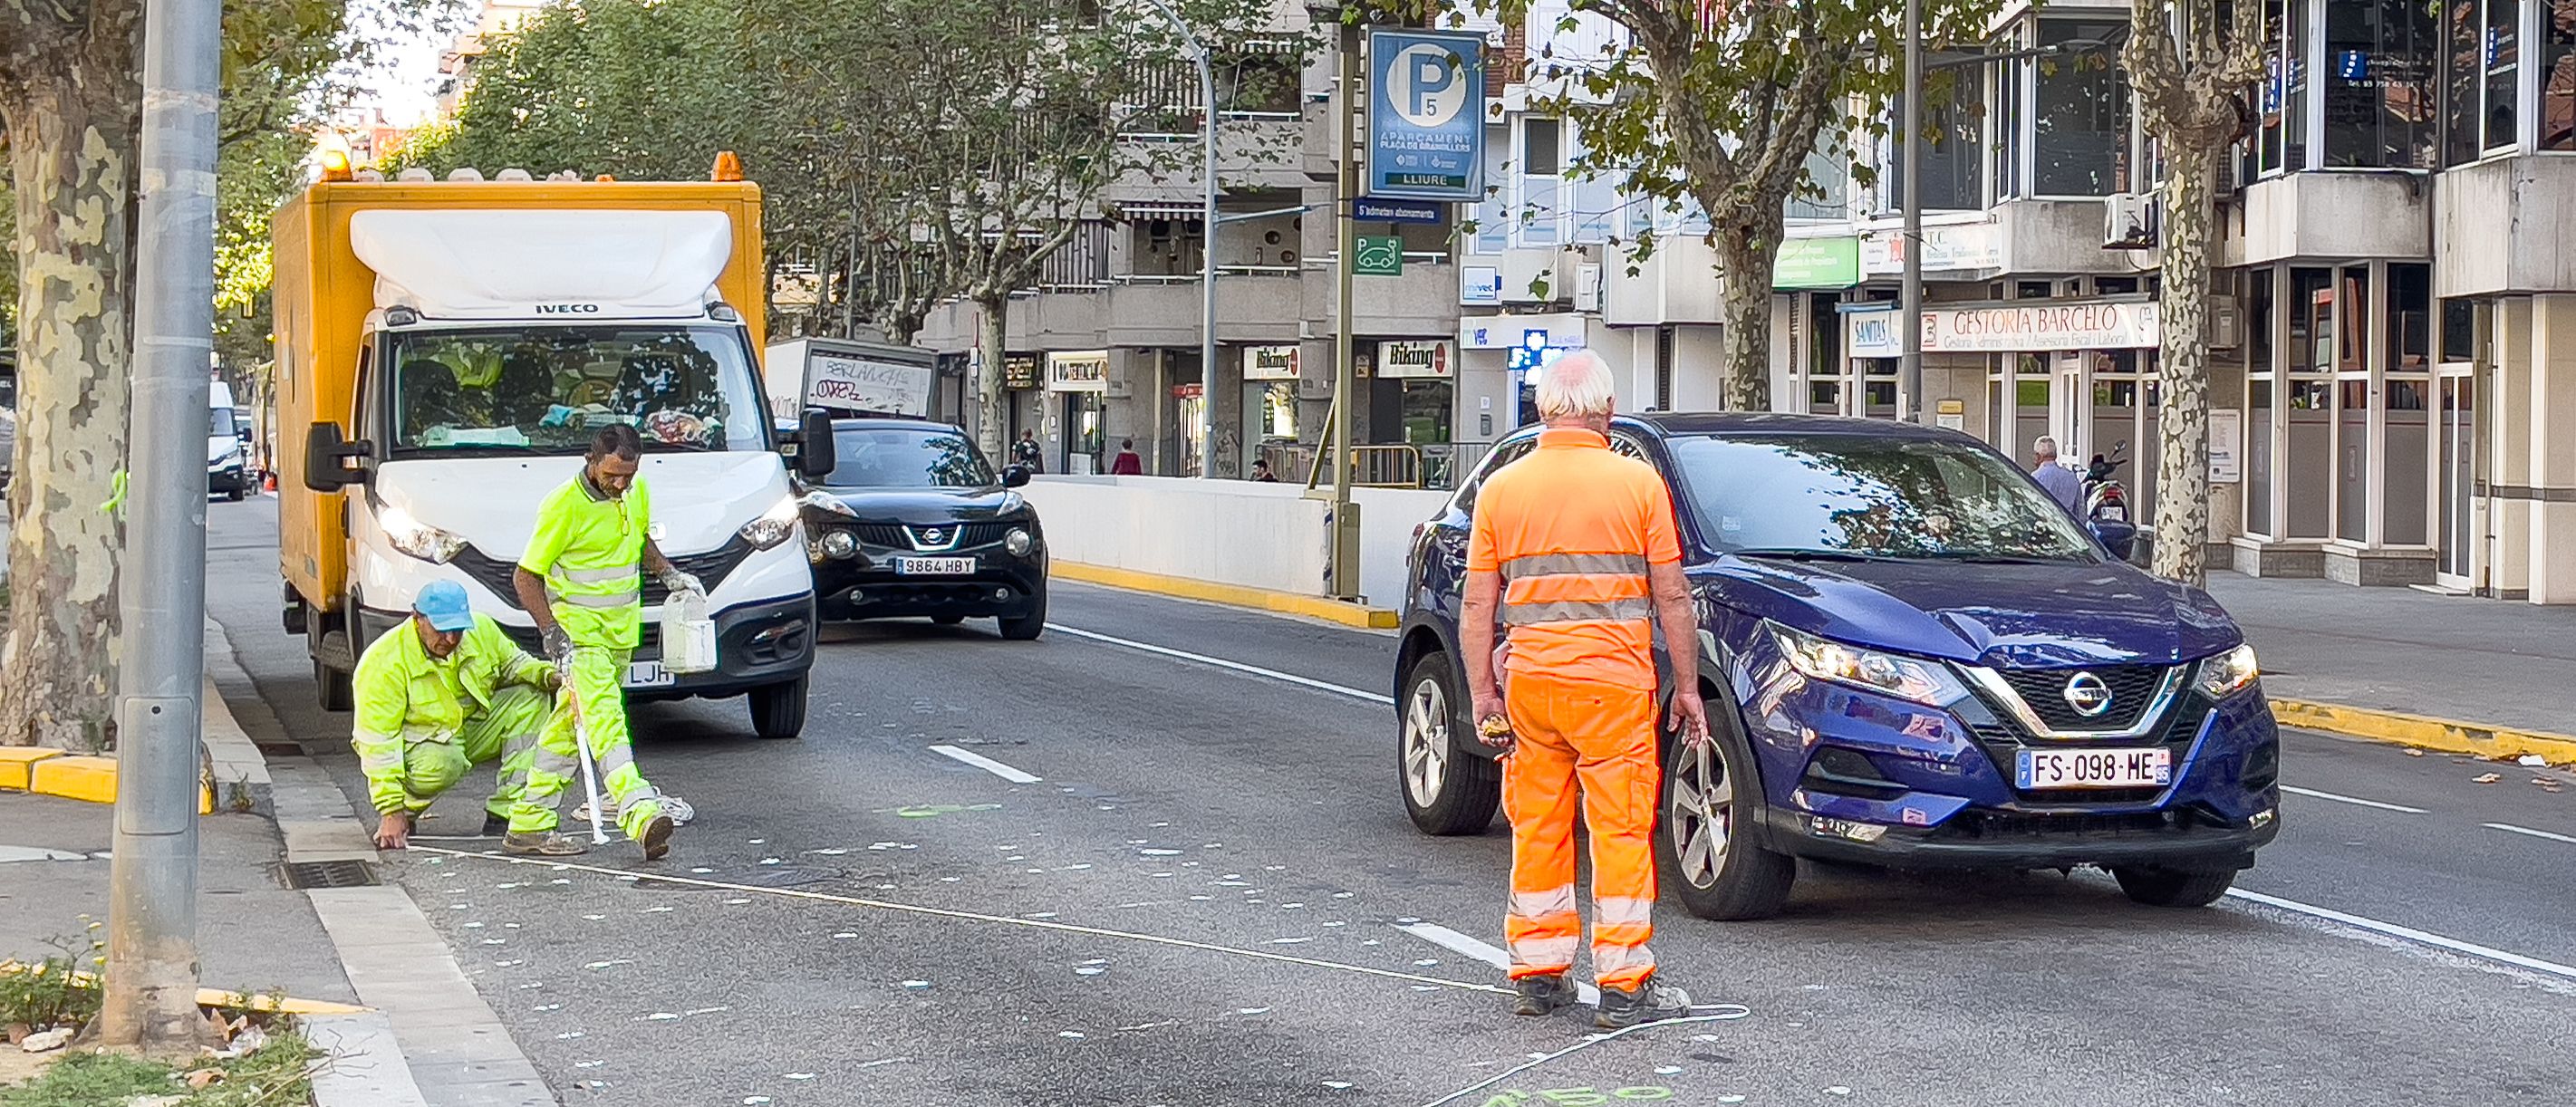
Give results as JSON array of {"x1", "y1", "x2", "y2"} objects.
[{"x1": 384, "y1": 324, "x2": 767, "y2": 453}]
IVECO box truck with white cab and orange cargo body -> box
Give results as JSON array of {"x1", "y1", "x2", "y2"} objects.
[{"x1": 273, "y1": 157, "x2": 832, "y2": 739}]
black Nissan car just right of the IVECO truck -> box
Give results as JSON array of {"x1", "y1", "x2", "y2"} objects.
[{"x1": 804, "y1": 419, "x2": 1046, "y2": 641}]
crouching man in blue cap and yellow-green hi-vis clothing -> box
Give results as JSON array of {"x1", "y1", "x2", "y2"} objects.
[{"x1": 351, "y1": 582, "x2": 564, "y2": 852}]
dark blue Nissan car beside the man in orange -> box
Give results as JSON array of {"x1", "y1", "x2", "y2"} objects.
[{"x1": 1396, "y1": 415, "x2": 2280, "y2": 919}]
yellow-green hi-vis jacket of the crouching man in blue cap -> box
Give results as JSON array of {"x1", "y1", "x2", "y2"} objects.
[{"x1": 351, "y1": 612, "x2": 551, "y2": 813}]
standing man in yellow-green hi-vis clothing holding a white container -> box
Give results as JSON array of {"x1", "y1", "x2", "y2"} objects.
[{"x1": 502, "y1": 425, "x2": 706, "y2": 860}]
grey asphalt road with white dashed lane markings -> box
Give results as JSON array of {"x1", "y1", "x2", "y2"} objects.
[{"x1": 211, "y1": 499, "x2": 2576, "y2": 1107}]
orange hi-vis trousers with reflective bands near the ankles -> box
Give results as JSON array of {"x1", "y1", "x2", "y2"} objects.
[{"x1": 1501, "y1": 672, "x2": 1662, "y2": 991}]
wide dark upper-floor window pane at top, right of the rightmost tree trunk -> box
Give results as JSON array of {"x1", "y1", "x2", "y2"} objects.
[{"x1": 2323, "y1": 0, "x2": 2439, "y2": 170}]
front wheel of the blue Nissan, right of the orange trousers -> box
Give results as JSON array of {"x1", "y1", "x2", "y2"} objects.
[{"x1": 1654, "y1": 698, "x2": 1798, "y2": 921}]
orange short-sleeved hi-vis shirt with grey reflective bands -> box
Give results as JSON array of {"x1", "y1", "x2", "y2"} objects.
[{"x1": 1466, "y1": 428, "x2": 1682, "y2": 690}]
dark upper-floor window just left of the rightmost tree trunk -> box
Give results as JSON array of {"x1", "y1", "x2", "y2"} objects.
[{"x1": 2030, "y1": 21, "x2": 2127, "y2": 196}]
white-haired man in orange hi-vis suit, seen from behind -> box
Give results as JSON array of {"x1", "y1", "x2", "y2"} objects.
[{"x1": 1461, "y1": 350, "x2": 1708, "y2": 1027}]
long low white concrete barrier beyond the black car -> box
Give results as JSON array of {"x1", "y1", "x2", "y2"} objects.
[{"x1": 1023, "y1": 476, "x2": 1451, "y2": 608}]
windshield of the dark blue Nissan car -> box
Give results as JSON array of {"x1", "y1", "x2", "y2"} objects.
[{"x1": 1669, "y1": 435, "x2": 2099, "y2": 562}]
